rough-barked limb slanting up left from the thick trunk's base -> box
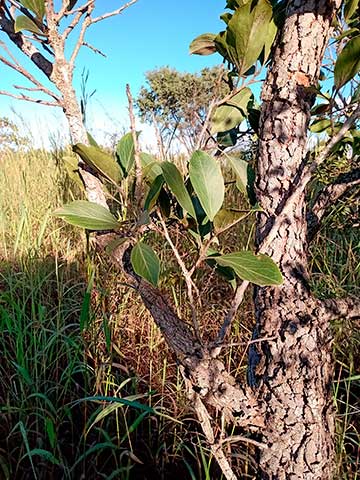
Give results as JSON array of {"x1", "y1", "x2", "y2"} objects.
[{"x1": 96, "y1": 233, "x2": 263, "y2": 430}]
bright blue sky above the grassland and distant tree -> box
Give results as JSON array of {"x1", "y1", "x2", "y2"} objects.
[{"x1": 0, "y1": 0, "x2": 225, "y2": 146}]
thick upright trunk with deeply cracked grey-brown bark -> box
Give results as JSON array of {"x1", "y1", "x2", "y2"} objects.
[{"x1": 249, "y1": 0, "x2": 340, "y2": 480}]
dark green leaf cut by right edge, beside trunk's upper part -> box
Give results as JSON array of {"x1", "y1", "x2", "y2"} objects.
[{"x1": 334, "y1": 36, "x2": 360, "y2": 89}]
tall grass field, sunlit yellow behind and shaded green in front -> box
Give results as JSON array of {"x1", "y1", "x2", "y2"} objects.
[{"x1": 0, "y1": 150, "x2": 360, "y2": 480}]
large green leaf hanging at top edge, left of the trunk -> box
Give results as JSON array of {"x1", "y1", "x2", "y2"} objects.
[{"x1": 226, "y1": 0, "x2": 273, "y2": 75}]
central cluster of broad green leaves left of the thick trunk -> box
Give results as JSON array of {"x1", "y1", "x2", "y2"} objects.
[{"x1": 55, "y1": 133, "x2": 282, "y2": 286}]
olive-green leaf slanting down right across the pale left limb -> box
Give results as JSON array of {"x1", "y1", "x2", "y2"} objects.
[{"x1": 72, "y1": 143, "x2": 122, "y2": 184}]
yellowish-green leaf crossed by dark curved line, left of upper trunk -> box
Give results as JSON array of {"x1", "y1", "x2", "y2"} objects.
[{"x1": 211, "y1": 87, "x2": 252, "y2": 134}]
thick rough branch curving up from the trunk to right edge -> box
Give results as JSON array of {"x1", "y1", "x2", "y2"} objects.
[{"x1": 307, "y1": 168, "x2": 360, "y2": 240}]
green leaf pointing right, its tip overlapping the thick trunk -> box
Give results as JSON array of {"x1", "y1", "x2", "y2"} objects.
[{"x1": 213, "y1": 250, "x2": 283, "y2": 286}]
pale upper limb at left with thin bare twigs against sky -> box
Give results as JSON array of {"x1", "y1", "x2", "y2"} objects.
[{"x1": 0, "y1": 0, "x2": 137, "y2": 206}]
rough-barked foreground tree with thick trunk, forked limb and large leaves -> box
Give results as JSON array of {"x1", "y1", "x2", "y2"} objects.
[{"x1": 4, "y1": 0, "x2": 360, "y2": 480}]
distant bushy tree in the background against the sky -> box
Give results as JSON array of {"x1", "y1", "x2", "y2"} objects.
[{"x1": 136, "y1": 67, "x2": 230, "y2": 156}]
